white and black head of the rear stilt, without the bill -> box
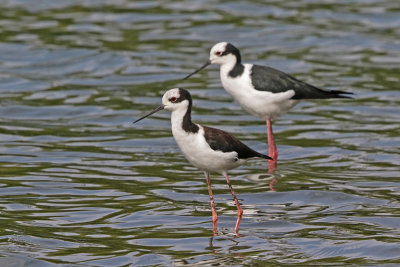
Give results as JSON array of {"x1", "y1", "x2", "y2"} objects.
[{"x1": 209, "y1": 42, "x2": 241, "y2": 65}]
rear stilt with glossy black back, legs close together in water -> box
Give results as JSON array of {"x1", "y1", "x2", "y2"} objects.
[{"x1": 184, "y1": 42, "x2": 352, "y2": 172}]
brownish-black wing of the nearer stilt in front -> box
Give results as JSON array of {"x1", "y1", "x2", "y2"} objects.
[{"x1": 203, "y1": 126, "x2": 270, "y2": 159}]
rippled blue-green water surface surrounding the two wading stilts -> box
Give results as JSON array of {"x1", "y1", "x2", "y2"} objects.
[{"x1": 0, "y1": 0, "x2": 400, "y2": 266}]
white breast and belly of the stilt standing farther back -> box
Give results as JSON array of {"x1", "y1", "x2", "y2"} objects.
[{"x1": 220, "y1": 64, "x2": 298, "y2": 119}]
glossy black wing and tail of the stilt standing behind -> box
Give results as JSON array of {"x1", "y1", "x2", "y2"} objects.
[{"x1": 251, "y1": 65, "x2": 352, "y2": 99}]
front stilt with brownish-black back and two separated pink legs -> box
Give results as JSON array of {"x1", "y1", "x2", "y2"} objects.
[{"x1": 134, "y1": 88, "x2": 271, "y2": 235}]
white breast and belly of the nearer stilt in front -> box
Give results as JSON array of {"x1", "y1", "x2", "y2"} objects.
[{"x1": 172, "y1": 126, "x2": 243, "y2": 173}]
